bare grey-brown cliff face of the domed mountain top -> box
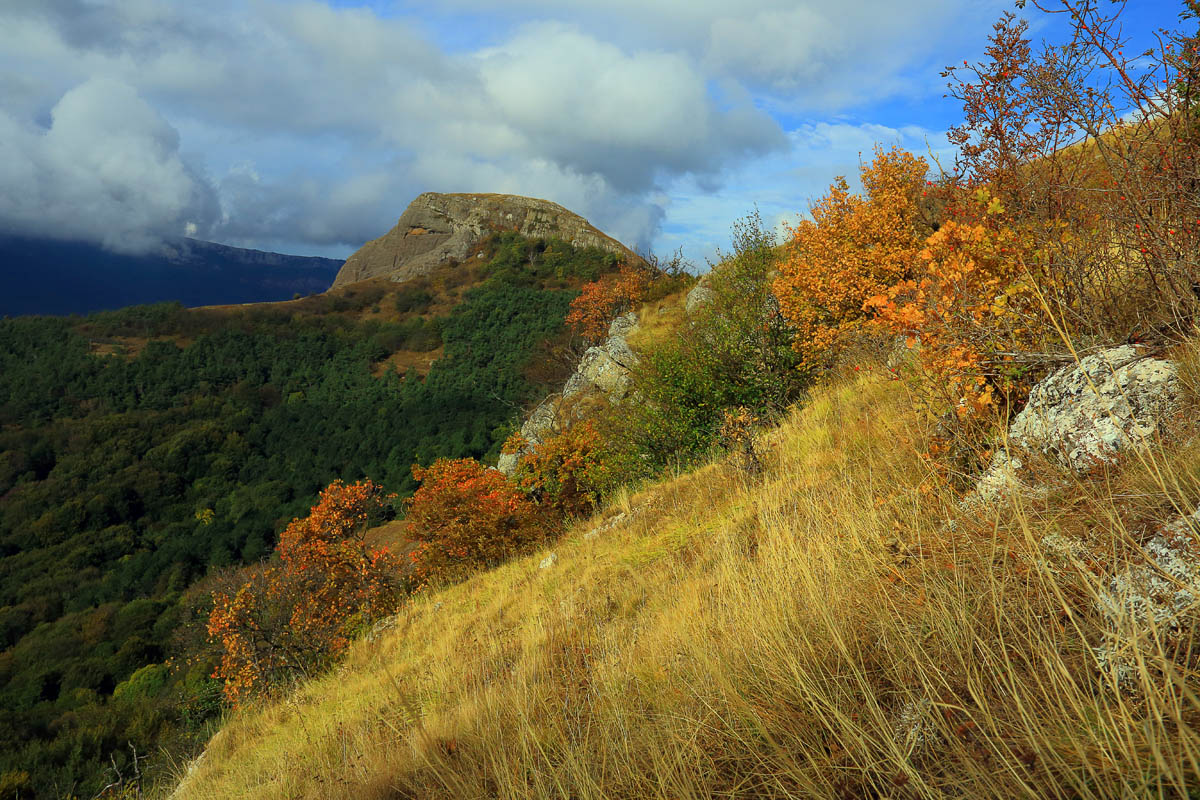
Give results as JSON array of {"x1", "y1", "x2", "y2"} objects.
[{"x1": 334, "y1": 192, "x2": 637, "y2": 287}]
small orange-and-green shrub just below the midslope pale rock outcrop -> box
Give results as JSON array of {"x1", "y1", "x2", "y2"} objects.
[{"x1": 514, "y1": 420, "x2": 612, "y2": 517}]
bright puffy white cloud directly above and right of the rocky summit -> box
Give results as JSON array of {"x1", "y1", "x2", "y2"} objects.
[{"x1": 481, "y1": 24, "x2": 784, "y2": 192}]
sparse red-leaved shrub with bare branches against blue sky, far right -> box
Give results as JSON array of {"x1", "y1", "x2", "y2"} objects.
[{"x1": 943, "y1": 0, "x2": 1200, "y2": 344}]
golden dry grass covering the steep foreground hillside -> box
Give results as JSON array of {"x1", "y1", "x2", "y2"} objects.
[{"x1": 164, "y1": 359, "x2": 1200, "y2": 800}]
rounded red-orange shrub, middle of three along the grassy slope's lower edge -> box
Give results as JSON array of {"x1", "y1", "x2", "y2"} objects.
[{"x1": 406, "y1": 458, "x2": 550, "y2": 584}]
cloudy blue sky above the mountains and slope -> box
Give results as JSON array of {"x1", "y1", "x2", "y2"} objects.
[{"x1": 0, "y1": 0, "x2": 1181, "y2": 266}]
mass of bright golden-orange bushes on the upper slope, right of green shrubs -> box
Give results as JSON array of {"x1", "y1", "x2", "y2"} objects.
[{"x1": 774, "y1": 148, "x2": 1062, "y2": 462}]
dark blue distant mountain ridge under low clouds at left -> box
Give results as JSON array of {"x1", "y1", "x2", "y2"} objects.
[{"x1": 0, "y1": 235, "x2": 342, "y2": 315}]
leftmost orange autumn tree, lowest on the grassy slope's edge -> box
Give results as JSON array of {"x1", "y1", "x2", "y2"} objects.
[{"x1": 208, "y1": 481, "x2": 401, "y2": 704}]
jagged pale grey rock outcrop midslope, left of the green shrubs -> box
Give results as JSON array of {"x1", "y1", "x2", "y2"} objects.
[{"x1": 496, "y1": 312, "x2": 637, "y2": 475}]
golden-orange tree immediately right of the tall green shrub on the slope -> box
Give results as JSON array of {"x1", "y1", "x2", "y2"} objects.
[{"x1": 774, "y1": 148, "x2": 929, "y2": 367}]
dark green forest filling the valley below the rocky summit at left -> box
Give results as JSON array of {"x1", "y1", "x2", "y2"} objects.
[{"x1": 0, "y1": 234, "x2": 616, "y2": 798}]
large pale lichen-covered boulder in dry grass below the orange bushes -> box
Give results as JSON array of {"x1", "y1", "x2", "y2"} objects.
[{"x1": 972, "y1": 345, "x2": 1180, "y2": 501}]
